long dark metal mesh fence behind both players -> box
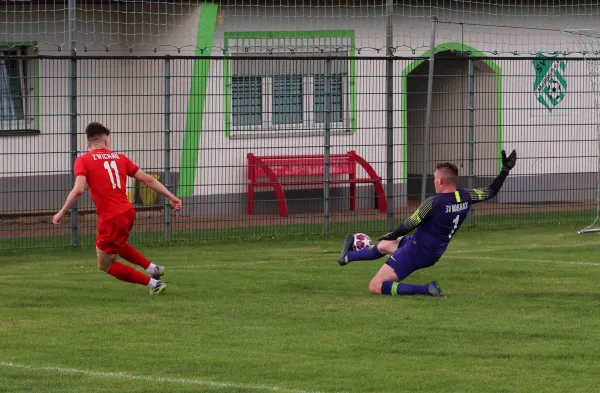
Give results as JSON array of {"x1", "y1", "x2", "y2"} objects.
[{"x1": 0, "y1": 52, "x2": 598, "y2": 249}]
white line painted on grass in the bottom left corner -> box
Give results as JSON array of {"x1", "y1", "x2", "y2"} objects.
[{"x1": 0, "y1": 362, "x2": 336, "y2": 393}]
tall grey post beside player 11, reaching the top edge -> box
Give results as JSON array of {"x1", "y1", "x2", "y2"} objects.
[{"x1": 69, "y1": 0, "x2": 79, "y2": 247}]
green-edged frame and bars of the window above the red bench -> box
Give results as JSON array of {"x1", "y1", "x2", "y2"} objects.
[{"x1": 223, "y1": 30, "x2": 356, "y2": 138}]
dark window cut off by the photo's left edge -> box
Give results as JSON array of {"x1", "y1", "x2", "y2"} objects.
[{"x1": 0, "y1": 47, "x2": 35, "y2": 133}]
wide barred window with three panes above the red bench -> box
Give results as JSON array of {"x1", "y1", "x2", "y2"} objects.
[{"x1": 228, "y1": 38, "x2": 350, "y2": 134}]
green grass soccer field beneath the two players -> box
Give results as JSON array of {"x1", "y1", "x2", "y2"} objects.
[{"x1": 0, "y1": 225, "x2": 600, "y2": 393}]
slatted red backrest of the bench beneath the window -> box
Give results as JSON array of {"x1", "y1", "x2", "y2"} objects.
[{"x1": 248, "y1": 154, "x2": 356, "y2": 180}]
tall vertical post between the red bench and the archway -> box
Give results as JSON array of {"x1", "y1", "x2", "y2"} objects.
[{"x1": 385, "y1": 0, "x2": 396, "y2": 231}]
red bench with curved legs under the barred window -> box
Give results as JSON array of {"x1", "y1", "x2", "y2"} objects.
[{"x1": 248, "y1": 151, "x2": 387, "y2": 217}]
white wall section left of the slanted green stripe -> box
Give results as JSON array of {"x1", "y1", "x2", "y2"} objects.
[{"x1": 0, "y1": 4, "x2": 200, "y2": 177}]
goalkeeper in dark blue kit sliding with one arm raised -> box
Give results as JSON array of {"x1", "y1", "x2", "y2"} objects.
[{"x1": 338, "y1": 150, "x2": 517, "y2": 296}]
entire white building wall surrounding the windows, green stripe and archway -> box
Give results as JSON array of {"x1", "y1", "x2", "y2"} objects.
[{"x1": 0, "y1": 4, "x2": 597, "y2": 202}]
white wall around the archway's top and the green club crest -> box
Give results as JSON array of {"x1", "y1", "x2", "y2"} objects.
[{"x1": 398, "y1": 19, "x2": 600, "y2": 175}]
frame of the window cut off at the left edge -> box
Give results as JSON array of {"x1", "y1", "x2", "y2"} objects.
[{"x1": 0, "y1": 42, "x2": 40, "y2": 136}]
